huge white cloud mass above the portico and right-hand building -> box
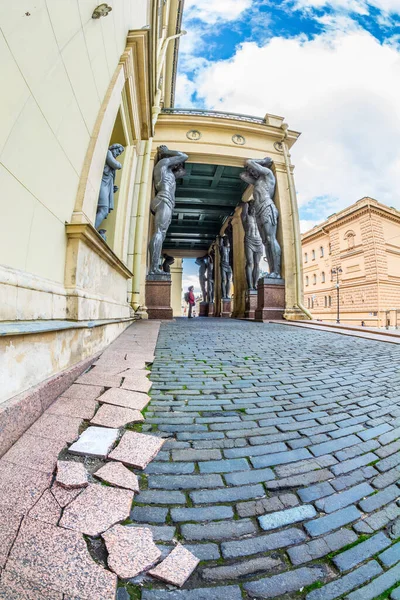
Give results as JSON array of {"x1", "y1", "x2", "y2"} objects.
[{"x1": 185, "y1": 28, "x2": 400, "y2": 220}]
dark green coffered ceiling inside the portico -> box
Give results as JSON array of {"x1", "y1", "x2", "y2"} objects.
[{"x1": 163, "y1": 163, "x2": 247, "y2": 254}]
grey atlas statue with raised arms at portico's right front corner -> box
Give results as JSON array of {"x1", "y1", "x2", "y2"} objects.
[{"x1": 240, "y1": 156, "x2": 281, "y2": 279}]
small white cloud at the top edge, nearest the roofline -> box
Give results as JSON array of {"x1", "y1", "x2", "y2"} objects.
[{"x1": 185, "y1": 0, "x2": 252, "y2": 25}]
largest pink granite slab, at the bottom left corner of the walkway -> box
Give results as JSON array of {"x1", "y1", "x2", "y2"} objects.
[{"x1": 6, "y1": 517, "x2": 117, "y2": 600}]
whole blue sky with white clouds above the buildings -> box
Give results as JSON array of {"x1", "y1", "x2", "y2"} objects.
[{"x1": 175, "y1": 0, "x2": 400, "y2": 234}]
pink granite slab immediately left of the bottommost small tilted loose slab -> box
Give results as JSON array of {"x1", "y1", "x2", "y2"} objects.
[{"x1": 102, "y1": 525, "x2": 161, "y2": 579}]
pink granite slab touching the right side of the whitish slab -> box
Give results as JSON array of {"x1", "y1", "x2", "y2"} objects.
[{"x1": 108, "y1": 431, "x2": 165, "y2": 469}]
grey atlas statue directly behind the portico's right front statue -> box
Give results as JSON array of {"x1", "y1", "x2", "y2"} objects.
[{"x1": 241, "y1": 201, "x2": 263, "y2": 290}]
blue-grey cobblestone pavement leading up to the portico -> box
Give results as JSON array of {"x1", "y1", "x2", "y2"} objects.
[{"x1": 136, "y1": 319, "x2": 400, "y2": 600}]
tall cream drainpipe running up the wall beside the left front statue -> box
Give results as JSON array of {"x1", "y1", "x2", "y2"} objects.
[{"x1": 132, "y1": 30, "x2": 186, "y2": 311}]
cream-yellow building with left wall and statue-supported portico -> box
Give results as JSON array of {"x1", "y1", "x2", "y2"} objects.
[{"x1": 0, "y1": 0, "x2": 307, "y2": 455}]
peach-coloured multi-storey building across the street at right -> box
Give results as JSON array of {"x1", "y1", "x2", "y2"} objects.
[{"x1": 302, "y1": 198, "x2": 400, "y2": 327}]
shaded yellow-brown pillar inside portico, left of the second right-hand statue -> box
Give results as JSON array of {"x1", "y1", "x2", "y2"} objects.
[{"x1": 231, "y1": 207, "x2": 247, "y2": 319}]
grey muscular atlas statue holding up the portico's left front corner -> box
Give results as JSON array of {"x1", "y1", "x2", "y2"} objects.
[{"x1": 149, "y1": 146, "x2": 188, "y2": 274}]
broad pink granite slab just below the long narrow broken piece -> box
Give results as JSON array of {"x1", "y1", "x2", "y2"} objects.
[{"x1": 60, "y1": 483, "x2": 133, "y2": 535}]
